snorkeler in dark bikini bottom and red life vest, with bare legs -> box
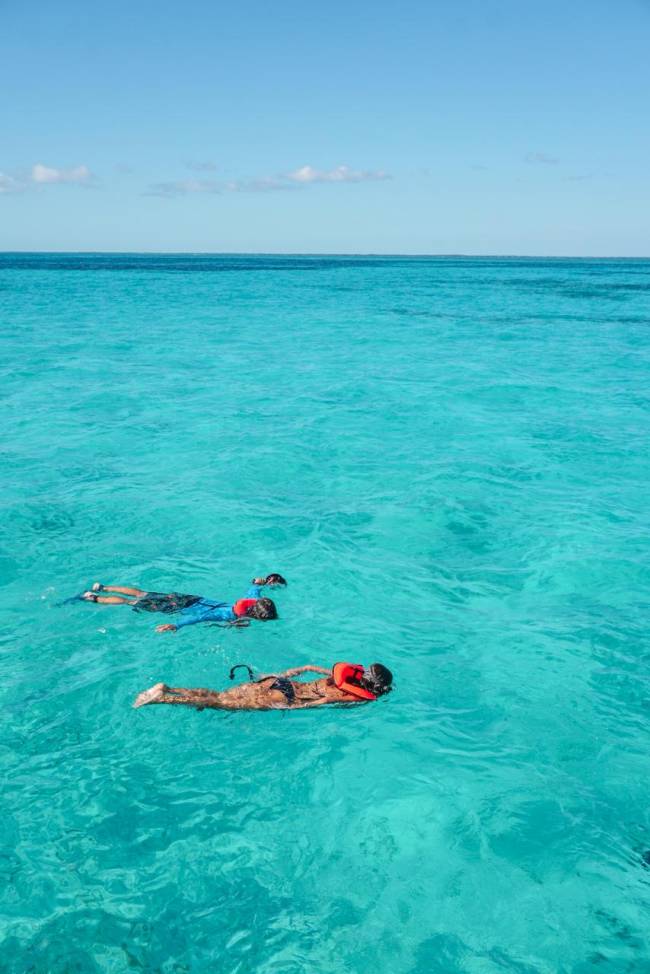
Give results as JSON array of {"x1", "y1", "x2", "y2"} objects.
[{"x1": 133, "y1": 663, "x2": 393, "y2": 710}]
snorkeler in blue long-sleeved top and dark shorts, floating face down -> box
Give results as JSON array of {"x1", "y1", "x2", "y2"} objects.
[{"x1": 81, "y1": 572, "x2": 287, "y2": 632}]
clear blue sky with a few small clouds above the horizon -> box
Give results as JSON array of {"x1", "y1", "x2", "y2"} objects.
[{"x1": 0, "y1": 0, "x2": 650, "y2": 256}]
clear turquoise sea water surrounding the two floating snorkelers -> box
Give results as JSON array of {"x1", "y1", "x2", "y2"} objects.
[{"x1": 0, "y1": 255, "x2": 650, "y2": 974}]
